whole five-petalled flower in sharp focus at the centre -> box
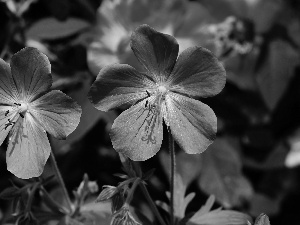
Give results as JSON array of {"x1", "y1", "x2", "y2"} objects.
[{"x1": 89, "y1": 25, "x2": 226, "y2": 160}]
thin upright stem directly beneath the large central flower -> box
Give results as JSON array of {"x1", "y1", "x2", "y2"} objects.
[{"x1": 168, "y1": 130, "x2": 176, "y2": 225}]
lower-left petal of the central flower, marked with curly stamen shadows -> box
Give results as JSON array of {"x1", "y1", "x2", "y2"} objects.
[{"x1": 110, "y1": 97, "x2": 163, "y2": 161}]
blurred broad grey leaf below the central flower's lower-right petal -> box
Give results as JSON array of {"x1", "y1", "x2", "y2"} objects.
[{"x1": 198, "y1": 139, "x2": 253, "y2": 207}]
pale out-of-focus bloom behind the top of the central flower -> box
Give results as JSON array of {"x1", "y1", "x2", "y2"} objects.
[{"x1": 87, "y1": 0, "x2": 213, "y2": 75}]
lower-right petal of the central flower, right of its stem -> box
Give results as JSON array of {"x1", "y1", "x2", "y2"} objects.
[{"x1": 166, "y1": 93, "x2": 217, "y2": 154}]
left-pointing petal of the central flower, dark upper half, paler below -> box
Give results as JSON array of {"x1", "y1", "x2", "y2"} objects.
[{"x1": 88, "y1": 64, "x2": 154, "y2": 111}]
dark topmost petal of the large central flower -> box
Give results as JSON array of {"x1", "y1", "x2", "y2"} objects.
[{"x1": 130, "y1": 25, "x2": 179, "y2": 82}]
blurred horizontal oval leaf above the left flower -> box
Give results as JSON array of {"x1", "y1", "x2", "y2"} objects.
[{"x1": 26, "y1": 17, "x2": 91, "y2": 40}]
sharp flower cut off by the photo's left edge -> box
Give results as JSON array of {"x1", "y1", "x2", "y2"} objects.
[{"x1": 0, "y1": 48, "x2": 81, "y2": 179}]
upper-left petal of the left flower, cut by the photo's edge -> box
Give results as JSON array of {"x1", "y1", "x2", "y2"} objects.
[{"x1": 0, "y1": 59, "x2": 18, "y2": 103}]
